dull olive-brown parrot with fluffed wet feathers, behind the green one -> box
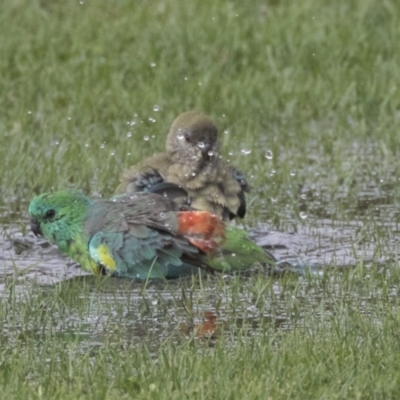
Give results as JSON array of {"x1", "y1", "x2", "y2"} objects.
[{"x1": 115, "y1": 111, "x2": 250, "y2": 221}]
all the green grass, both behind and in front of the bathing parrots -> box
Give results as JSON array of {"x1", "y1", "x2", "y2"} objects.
[{"x1": 0, "y1": 0, "x2": 400, "y2": 399}]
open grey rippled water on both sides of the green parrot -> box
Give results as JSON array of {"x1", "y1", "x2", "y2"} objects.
[{"x1": 0, "y1": 216, "x2": 388, "y2": 284}]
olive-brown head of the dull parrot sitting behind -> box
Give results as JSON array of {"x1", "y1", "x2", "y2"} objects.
[{"x1": 166, "y1": 111, "x2": 219, "y2": 169}]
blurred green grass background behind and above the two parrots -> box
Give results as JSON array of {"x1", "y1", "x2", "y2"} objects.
[{"x1": 0, "y1": 0, "x2": 400, "y2": 229}]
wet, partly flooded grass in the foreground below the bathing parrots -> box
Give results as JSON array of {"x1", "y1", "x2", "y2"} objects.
[{"x1": 0, "y1": 265, "x2": 400, "y2": 399}]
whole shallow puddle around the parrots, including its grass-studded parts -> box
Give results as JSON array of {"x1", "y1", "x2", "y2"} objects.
[{"x1": 0, "y1": 141, "x2": 400, "y2": 348}]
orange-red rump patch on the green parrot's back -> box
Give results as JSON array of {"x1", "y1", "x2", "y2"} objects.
[{"x1": 178, "y1": 211, "x2": 225, "y2": 253}]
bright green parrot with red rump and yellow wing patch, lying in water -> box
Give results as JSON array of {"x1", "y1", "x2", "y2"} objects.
[{"x1": 29, "y1": 189, "x2": 276, "y2": 280}]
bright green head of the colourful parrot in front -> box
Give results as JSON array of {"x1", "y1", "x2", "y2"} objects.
[{"x1": 29, "y1": 190, "x2": 90, "y2": 250}]
